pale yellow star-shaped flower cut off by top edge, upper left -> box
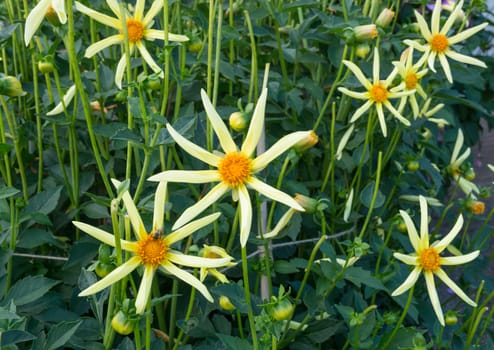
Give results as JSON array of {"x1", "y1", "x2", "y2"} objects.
[{"x1": 75, "y1": 0, "x2": 189, "y2": 89}]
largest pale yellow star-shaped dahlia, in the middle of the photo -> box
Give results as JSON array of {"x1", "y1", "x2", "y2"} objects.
[{"x1": 149, "y1": 88, "x2": 312, "y2": 247}]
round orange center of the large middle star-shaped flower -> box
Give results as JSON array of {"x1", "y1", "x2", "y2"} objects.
[{"x1": 218, "y1": 152, "x2": 252, "y2": 187}]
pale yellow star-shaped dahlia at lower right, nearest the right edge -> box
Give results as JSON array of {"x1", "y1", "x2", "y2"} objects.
[{"x1": 391, "y1": 196, "x2": 479, "y2": 326}]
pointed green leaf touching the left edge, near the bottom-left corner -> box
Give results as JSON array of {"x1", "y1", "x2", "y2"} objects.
[{"x1": 2, "y1": 275, "x2": 60, "y2": 306}]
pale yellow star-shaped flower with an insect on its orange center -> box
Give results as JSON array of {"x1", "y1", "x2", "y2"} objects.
[{"x1": 73, "y1": 180, "x2": 232, "y2": 314}]
